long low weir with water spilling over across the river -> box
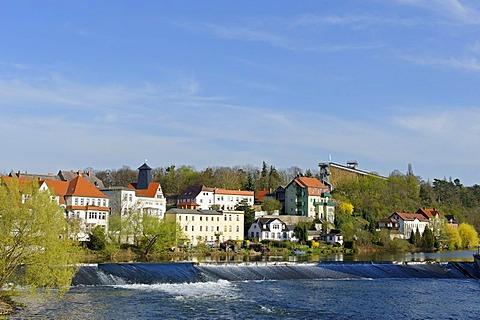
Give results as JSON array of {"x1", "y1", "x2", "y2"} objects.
[{"x1": 73, "y1": 262, "x2": 480, "y2": 285}]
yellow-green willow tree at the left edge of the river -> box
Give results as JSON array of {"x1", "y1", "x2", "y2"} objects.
[{"x1": 0, "y1": 178, "x2": 75, "y2": 290}]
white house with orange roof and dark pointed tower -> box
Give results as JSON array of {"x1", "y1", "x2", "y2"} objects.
[{"x1": 101, "y1": 163, "x2": 167, "y2": 219}]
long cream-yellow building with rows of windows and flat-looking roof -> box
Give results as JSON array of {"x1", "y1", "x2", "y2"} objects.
[{"x1": 165, "y1": 209, "x2": 246, "y2": 246}]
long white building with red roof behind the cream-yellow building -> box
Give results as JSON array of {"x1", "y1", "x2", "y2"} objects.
[{"x1": 177, "y1": 184, "x2": 254, "y2": 211}]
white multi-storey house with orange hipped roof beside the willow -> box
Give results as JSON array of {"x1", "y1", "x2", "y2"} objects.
[{"x1": 62, "y1": 172, "x2": 110, "y2": 241}]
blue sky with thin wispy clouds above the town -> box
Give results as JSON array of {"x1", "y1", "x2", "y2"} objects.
[{"x1": 0, "y1": 0, "x2": 480, "y2": 185}]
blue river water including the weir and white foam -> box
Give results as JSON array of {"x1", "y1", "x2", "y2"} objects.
[{"x1": 11, "y1": 251, "x2": 480, "y2": 320}]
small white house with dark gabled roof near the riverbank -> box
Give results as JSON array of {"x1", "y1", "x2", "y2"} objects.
[{"x1": 247, "y1": 218, "x2": 297, "y2": 241}]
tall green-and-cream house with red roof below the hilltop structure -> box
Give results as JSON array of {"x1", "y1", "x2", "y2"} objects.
[{"x1": 285, "y1": 177, "x2": 335, "y2": 224}]
